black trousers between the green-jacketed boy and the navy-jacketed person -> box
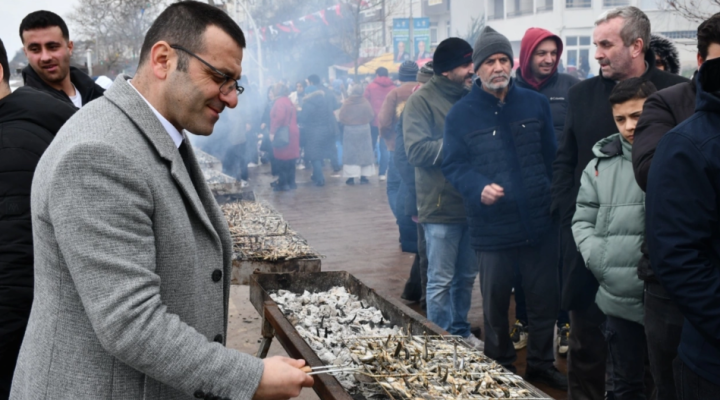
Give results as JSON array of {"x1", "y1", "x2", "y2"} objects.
[{"x1": 645, "y1": 282, "x2": 684, "y2": 400}]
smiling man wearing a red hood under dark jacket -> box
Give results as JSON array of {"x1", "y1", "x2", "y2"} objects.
[{"x1": 511, "y1": 28, "x2": 580, "y2": 356}]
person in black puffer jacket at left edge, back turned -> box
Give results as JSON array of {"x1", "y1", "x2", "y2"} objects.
[{"x1": 0, "y1": 36, "x2": 75, "y2": 399}]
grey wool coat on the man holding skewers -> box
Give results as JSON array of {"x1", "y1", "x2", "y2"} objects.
[{"x1": 10, "y1": 76, "x2": 263, "y2": 400}]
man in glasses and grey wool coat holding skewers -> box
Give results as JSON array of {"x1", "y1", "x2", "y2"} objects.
[{"x1": 10, "y1": 1, "x2": 313, "y2": 400}]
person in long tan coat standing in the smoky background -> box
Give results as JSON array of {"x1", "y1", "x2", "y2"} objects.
[{"x1": 338, "y1": 85, "x2": 375, "y2": 185}]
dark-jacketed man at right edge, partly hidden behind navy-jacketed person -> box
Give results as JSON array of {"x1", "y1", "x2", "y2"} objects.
[{"x1": 632, "y1": 13, "x2": 720, "y2": 400}]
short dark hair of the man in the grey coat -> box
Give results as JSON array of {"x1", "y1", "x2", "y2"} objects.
[{"x1": 139, "y1": 1, "x2": 245, "y2": 71}]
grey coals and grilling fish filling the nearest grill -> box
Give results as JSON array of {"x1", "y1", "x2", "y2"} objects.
[{"x1": 270, "y1": 287, "x2": 537, "y2": 400}]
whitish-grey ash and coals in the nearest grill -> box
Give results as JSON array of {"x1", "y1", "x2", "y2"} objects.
[{"x1": 270, "y1": 287, "x2": 402, "y2": 393}]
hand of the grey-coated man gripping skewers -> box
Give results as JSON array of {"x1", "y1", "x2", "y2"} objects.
[{"x1": 253, "y1": 356, "x2": 313, "y2": 400}]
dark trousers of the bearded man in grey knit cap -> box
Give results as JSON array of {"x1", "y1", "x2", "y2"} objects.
[{"x1": 477, "y1": 235, "x2": 560, "y2": 371}]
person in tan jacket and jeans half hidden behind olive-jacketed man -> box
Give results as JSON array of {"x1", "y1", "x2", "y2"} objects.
[{"x1": 378, "y1": 60, "x2": 420, "y2": 301}]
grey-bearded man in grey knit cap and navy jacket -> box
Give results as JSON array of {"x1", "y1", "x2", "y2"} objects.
[{"x1": 442, "y1": 27, "x2": 567, "y2": 389}]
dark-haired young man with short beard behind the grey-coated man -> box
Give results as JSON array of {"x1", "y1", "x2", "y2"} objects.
[{"x1": 20, "y1": 10, "x2": 105, "y2": 108}]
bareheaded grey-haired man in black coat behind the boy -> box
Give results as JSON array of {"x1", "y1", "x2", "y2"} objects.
[{"x1": 552, "y1": 7, "x2": 687, "y2": 400}]
